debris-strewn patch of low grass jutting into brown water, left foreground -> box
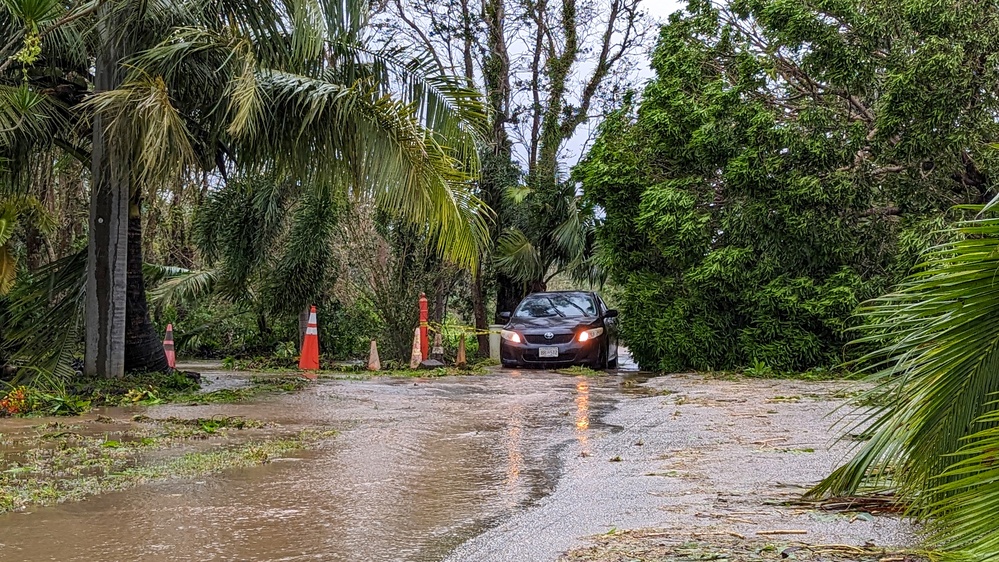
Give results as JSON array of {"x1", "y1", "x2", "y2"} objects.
[{"x1": 0, "y1": 416, "x2": 335, "y2": 513}]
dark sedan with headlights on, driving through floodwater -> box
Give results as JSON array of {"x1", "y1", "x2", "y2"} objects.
[{"x1": 500, "y1": 291, "x2": 617, "y2": 369}]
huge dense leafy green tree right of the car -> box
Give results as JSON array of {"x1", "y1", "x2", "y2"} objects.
[{"x1": 574, "y1": 0, "x2": 999, "y2": 372}]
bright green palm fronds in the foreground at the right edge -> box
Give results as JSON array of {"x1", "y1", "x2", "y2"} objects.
[{"x1": 812, "y1": 207, "x2": 999, "y2": 560}]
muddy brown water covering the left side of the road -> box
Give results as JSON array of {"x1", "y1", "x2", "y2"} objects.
[{"x1": 0, "y1": 371, "x2": 640, "y2": 561}]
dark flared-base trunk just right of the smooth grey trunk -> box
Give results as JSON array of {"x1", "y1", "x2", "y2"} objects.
[{"x1": 125, "y1": 192, "x2": 170, "y2": 371}]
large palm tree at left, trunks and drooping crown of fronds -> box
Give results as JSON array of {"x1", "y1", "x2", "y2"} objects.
[{"x1": 0, "y1": 0, "x2": 485, "y2": 376}]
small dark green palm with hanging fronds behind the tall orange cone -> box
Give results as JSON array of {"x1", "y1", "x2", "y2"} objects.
[{"x1": 150, "y1": 175, "x2": 346, "y2": 344}]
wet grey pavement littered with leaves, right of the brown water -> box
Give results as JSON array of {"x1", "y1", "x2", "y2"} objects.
[{"x1": 453, "y1": 374, "x2": 914, "y2": 562}]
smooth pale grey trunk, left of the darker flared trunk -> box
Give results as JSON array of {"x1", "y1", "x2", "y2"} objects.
[{"x1": 83, "y1": 24, "x2": 129, "y2": 378}]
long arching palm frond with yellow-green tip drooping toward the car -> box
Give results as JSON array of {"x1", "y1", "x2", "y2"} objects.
[{"x1": 238, "y1": 72, "x2": 489, "y2": 267}]
